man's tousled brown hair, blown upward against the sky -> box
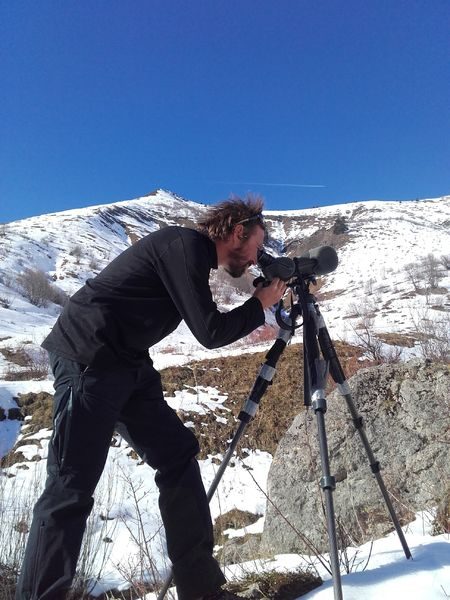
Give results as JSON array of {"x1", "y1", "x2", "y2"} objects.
[{"x1": 197, "y1": 194, "x2": 265, "y2": 241}]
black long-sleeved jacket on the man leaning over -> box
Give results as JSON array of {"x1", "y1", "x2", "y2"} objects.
[{"x1": 42, "y1": 227, "x2": 264, "y2": 366}]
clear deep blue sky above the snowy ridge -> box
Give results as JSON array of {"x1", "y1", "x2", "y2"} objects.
[{"x1": 0, "y1": 0, "x2": 450, "y2": 222}]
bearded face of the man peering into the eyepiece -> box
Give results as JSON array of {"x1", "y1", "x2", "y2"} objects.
[{"x1": 223, "y1": 225, "x2": 264, "y2": 277}]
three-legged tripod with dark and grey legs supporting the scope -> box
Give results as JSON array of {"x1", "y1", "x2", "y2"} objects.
[{"x1": 157, "y1": 275, "x2": 411, "y2": 600}]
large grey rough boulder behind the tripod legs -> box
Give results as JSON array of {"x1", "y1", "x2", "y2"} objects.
[{"x1": 262, "y1": 360, "x2": 450, "y2": 554}]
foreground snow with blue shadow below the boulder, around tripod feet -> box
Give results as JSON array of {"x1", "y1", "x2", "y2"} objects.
[{"x1": 221, "y1": 512, "x2": 450, "y2": 600}]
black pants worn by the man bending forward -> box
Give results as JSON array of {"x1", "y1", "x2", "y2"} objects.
[{"x1": 16, "y1": 355, "x2": 225, "y2": 600}]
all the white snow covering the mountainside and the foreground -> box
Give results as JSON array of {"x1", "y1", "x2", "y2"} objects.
[{"x1": 0, "y1": 190, "x2": 450, "y2": 600}]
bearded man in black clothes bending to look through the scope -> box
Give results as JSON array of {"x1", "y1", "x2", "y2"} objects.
[{"x1": 16, "y1": 198, "x2": 286, "y2": 600}]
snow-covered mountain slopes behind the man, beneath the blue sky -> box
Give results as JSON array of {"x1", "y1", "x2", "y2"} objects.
[{"x1": 0, "y1": 190, "x2": 450, "y2": 370}]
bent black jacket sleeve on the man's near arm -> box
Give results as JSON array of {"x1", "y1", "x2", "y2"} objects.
[{"x1": 155, "y1": 235, "x2": 265, "y2": 348}]
